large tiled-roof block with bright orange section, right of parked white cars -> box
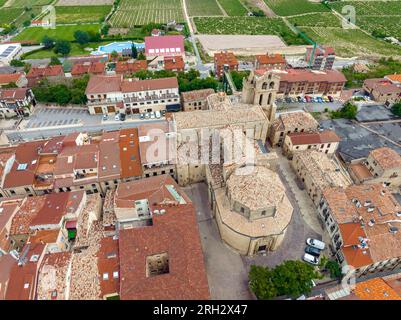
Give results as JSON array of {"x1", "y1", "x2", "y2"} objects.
[{"x1": 318, "y1": 184, "x2": 401, "y2": 277}]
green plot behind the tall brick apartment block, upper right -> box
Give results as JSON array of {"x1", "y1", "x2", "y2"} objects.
[{"x1": 302, "y1": 27, "x2": 401, "y2": 57}]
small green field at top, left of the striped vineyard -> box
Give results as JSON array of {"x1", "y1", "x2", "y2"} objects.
[{"x1": 56, "y1": 6, "x2": 112, "y2": 24}]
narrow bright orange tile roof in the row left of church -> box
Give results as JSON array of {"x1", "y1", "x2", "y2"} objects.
[{"x1": 119, "y1": 128, "x2": 142, "y2": 179}]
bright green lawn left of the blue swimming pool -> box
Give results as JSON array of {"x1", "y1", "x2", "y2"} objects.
[{"x1": 14, "y1": 24, "x2": 100, "y2": 43}]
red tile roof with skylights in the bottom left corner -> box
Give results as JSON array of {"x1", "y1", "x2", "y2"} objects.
[{"x1": 6, "y1": 244, "x2": 46, "y2": 300}]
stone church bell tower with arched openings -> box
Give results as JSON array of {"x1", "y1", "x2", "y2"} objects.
[{"x1": 242, "y1": 70, "x2": 280, "y2": 121}]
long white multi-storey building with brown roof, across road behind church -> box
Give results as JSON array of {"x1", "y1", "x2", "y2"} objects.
[{"x1": 86, "y1": 75, "x2": 180, "y2": 114}]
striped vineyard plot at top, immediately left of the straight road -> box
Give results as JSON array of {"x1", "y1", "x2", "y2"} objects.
[{"x1": 110, "y1": 0, "x2": 184, "y2": 28}]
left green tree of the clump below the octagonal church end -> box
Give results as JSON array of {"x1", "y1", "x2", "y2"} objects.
[{"x1": 249, "y1": 265, "x2": 277, "y2": 300}]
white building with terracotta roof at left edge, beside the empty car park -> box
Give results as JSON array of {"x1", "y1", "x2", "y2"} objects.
[{"x1": 0, "y1": 88, "x2": 36, "y2": 118}]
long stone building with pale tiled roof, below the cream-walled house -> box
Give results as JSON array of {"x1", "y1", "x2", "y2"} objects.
[{"x1": 291, "y1": 150, "x2": 352, "y2": 205}]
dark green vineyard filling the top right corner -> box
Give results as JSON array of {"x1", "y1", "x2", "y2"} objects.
[{"x1": 331, "y1": 0, "x2": 401, "y2": 40}]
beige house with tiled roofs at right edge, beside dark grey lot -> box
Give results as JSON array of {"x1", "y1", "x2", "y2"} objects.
[{"x1": 348, "y1": 147, "x2": 401, "y2": 188}]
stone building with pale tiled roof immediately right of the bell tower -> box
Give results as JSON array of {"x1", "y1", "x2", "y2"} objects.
[{"x1": 269, "y1": 111, "x2": 319, "y2": 147}]
